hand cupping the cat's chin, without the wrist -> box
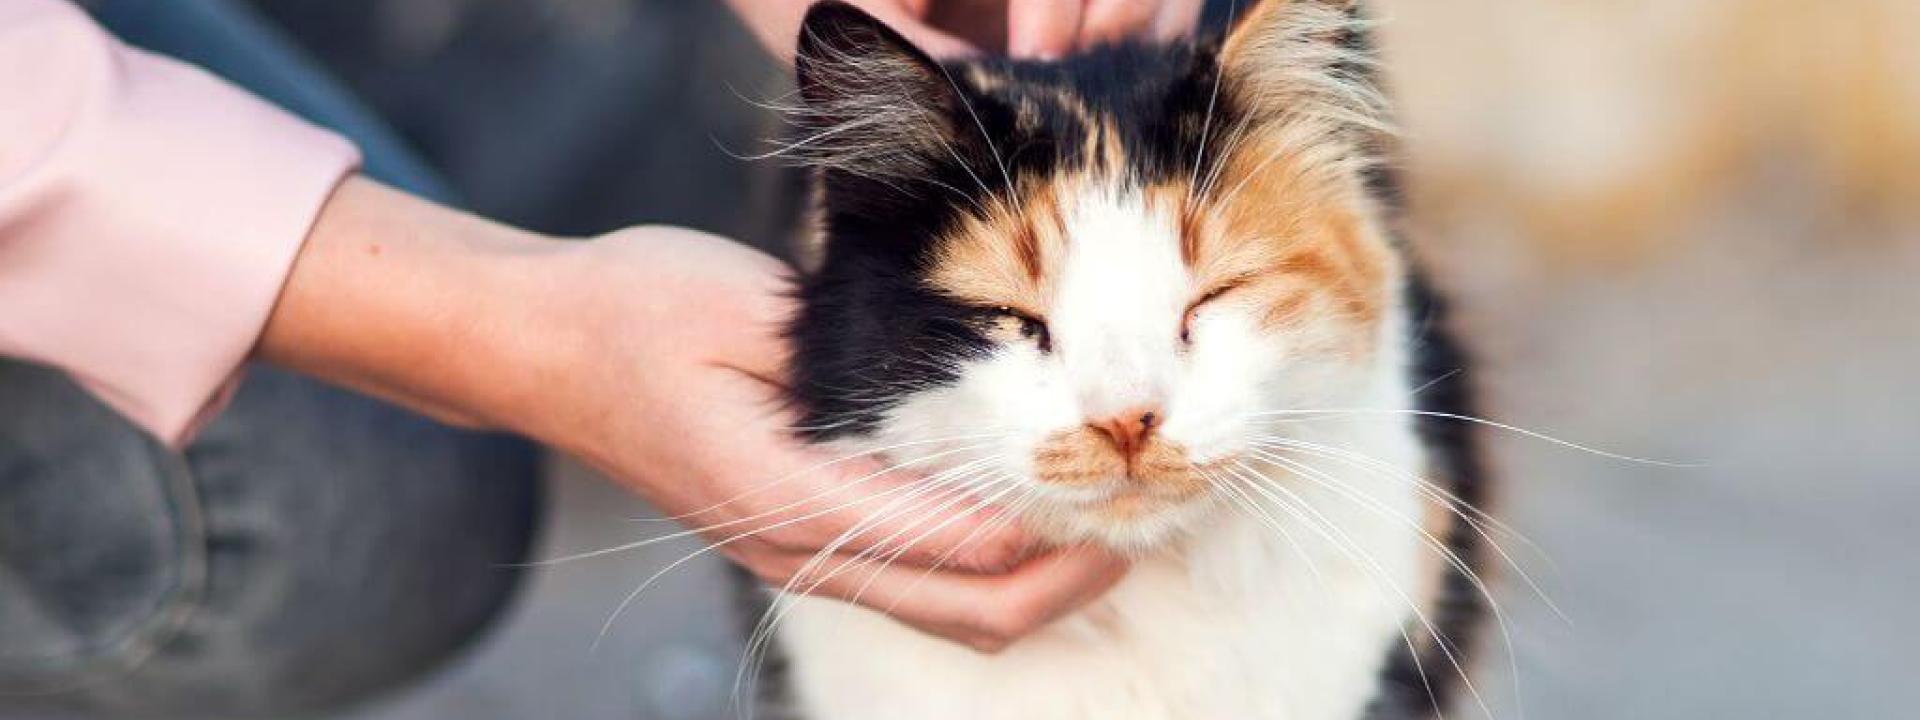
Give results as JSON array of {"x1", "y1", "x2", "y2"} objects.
[{"x1": 533, "y1": 227, "x2": 1123, "y2": 649}]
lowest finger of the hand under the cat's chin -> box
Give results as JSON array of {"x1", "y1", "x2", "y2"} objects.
[{"x1": 804, "y1": 547, "x2": 1127, "y2": 653}]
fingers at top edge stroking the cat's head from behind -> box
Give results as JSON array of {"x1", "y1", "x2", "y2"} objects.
[{"x1": 730, "y1": 0, "x2": 1204, "y2": 60}]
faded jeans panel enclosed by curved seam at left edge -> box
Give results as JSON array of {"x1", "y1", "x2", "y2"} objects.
[{"x1": 0, "y1": 361, "x2": 202, "y2": 705}]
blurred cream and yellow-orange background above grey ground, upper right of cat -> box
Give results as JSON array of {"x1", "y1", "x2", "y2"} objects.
[{"x1": 1380, "y1": 0, "x2": 1920, "y2": 269}]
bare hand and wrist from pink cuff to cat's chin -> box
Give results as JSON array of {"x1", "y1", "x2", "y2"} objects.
[{"x1": 259, "y1": 180, "x2": 1125, "y2": 651}]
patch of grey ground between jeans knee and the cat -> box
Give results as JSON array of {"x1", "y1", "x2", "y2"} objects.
[{"x1": 351, "y1": 461, "x2": 741, "y2": 720}]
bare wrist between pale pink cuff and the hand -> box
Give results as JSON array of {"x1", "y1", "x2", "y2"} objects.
[{"x1": 255, "y1": 179, "x2": 583, "y2": 437}]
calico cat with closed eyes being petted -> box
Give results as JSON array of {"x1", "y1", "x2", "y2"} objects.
[{"x1": 756, "y1": 0, "x2": 1488, "y2": 720}]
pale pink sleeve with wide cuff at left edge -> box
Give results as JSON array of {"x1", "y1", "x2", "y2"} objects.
[{"x1": 0, "y1": 0, "x2": 359, "y2": 444}]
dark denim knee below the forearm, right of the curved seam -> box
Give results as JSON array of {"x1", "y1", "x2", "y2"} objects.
[{"x1": 0, "y1": 366, "x2": 540, "y2": 718}]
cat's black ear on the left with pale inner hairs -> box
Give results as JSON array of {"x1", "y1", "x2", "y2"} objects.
[{"x1": 793, "y1": 0, "x2": 958, "y2": 180}]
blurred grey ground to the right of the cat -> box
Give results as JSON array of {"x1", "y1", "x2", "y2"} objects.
[{"x1": 1467, "y1": 202, "x2": 1920, "y2": 720}]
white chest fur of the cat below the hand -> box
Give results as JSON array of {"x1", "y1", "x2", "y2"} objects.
[{"x1": 783, "y1": 506, "x2": 1402, "y2": 720}]
